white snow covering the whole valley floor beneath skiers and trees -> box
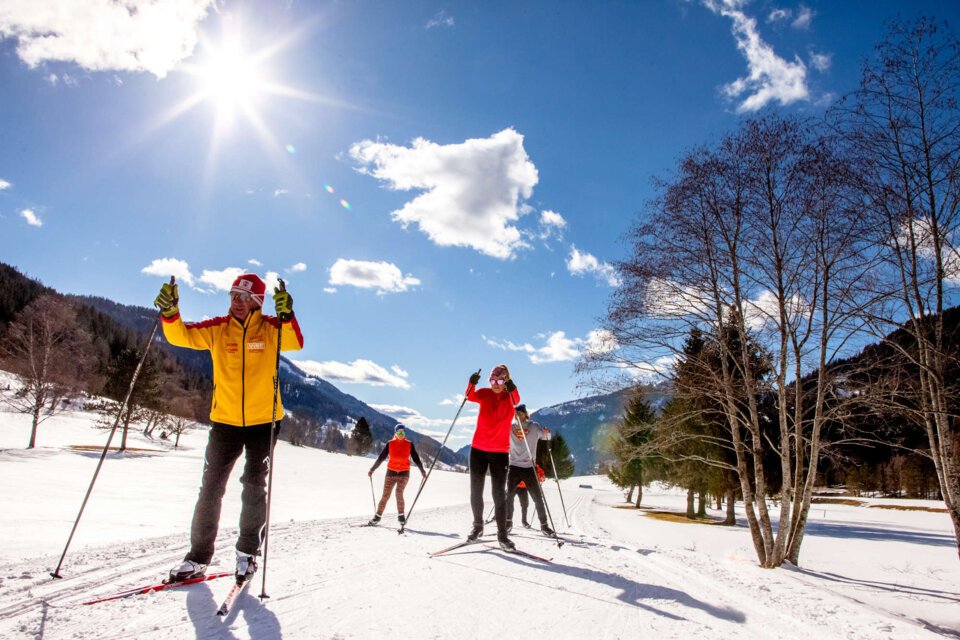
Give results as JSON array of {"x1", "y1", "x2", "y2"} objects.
[{"x1": 0, "y1": 384, "x2": 960, "y2": 640}]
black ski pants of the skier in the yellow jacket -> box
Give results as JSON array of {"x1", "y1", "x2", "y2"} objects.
[{"x1": 186, "y1": 422, "x2": 280, "y2": 564}]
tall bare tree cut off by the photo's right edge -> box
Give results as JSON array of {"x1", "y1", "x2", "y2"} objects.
[{"x1": 833, "y1": 18, "x2": 960, "y2": 554}]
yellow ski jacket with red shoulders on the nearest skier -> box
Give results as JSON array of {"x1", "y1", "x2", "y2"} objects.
[{"x1": 163, "y1": 309, "x2": 303, "y2": 427}]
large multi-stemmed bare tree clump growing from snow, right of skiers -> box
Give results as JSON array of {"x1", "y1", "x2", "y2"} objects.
[{"x1": 581, "y1": 117, "x2": 870, "y2": 567}]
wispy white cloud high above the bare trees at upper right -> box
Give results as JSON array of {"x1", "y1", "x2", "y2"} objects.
[{"x1": 703, "y1": 0, "x2": 810, "y2": 113}]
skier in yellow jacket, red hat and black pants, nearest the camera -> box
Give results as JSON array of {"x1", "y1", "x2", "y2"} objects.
[{"x1": 154, "y1": 274, "x2": 303, "y2": 582}]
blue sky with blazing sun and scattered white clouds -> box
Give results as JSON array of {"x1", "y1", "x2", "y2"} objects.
[{"x1": 0, "y1": 0, "x2": 960, "y2": 446}]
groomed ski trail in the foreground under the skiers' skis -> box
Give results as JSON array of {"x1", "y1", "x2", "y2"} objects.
[{"x1": 0, "y1": 489, "x2": 942, "y2": 640}]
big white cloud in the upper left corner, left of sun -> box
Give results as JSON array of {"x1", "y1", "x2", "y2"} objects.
[{"x1": 0, "y1": 0, "x2": 215, "y2": 81}]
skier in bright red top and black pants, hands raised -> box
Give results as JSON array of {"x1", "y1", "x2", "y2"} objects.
[{"x1": 466, "y1": 364, "x2": 520, "y2": 551}]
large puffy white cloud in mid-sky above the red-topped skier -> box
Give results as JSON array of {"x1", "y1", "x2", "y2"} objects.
[{"x1": 350, "y1": 129, "x2": 539, "y2": 260}]
